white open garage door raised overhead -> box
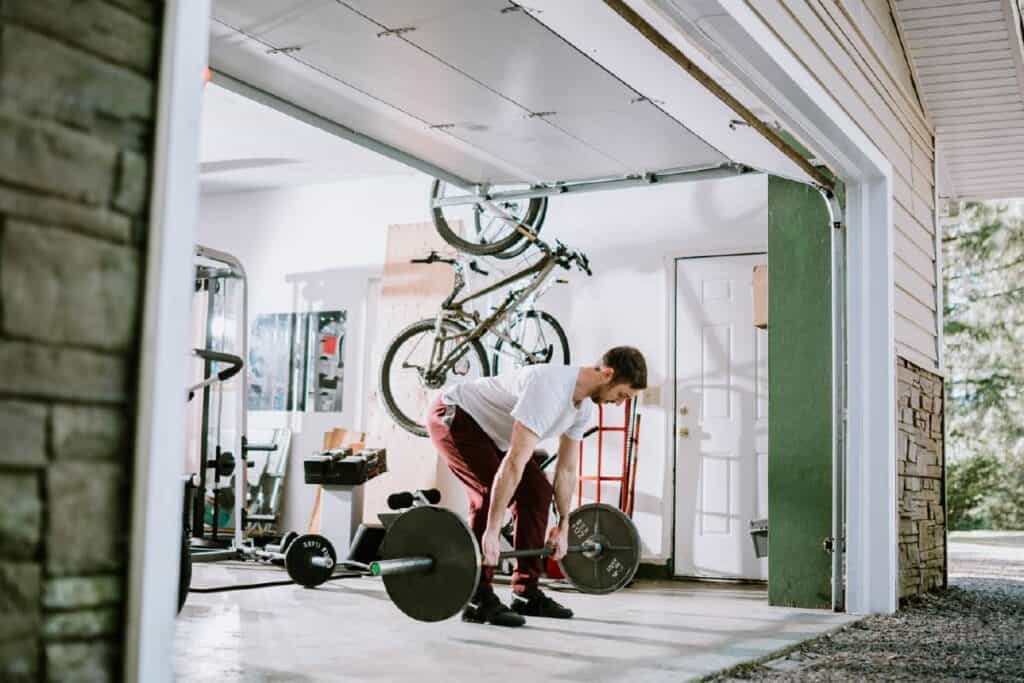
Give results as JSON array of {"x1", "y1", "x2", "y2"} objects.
[{"x1": 210, "y1": 0, "x2": 738, "y2": 185}]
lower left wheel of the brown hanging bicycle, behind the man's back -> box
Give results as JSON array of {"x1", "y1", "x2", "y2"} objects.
[{"x1": 380, "y1": 318, "x2": 488, "y2": 436}]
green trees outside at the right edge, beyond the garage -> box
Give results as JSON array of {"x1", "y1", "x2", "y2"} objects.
[{"x1": 942, "y1": 202, "x2": 1024, "y2": 528}]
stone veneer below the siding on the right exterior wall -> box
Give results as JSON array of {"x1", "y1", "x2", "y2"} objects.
[{"x1": 896, "y1": 358, "x2": 946, "y2": 598}]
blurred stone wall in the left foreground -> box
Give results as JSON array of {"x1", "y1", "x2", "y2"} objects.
[{"x1": 0, "y1": 0, "x2": 160, "y2": 681}]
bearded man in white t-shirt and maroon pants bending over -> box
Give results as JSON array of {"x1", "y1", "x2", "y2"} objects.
[{"x1": 427, "y1": 346, "x2": 647, "y2": 626}]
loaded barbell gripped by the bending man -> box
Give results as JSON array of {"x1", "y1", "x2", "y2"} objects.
[{"x1": 368, "y1": 503, "x2": 640, "y2": 622}]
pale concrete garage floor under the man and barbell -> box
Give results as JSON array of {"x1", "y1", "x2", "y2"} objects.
[{"x1": 175, "y1": 564, "x2": 856, "y2": 683}]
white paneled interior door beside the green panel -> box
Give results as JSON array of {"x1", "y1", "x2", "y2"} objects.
[{"x1": 675, "y1": 254, "x2": 768, "y2": 580}]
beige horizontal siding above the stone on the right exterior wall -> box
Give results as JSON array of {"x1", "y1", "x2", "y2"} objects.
[{"x1": 746, "y1": 0, "x2": 938, "y2": 370}]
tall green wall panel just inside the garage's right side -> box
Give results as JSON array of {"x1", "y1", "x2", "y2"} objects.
[{"x1": 768, "y1": 176, "x2": 833, "y2": 607}]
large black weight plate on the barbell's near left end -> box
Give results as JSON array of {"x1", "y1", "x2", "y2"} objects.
[{"x1": 380, "y1": 506, "x2": 480, "y2": 622}]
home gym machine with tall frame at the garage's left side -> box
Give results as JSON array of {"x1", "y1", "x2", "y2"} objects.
[{"x1": 178, "y1": 246, "x2": 319, "y2": 610}]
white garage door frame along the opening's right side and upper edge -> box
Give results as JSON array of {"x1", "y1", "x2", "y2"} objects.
[{"x1": 647, "y1": 0, "x2": 898, "y2": 613}]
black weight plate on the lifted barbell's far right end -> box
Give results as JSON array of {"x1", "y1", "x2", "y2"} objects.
[{"x1": 558, "y1": 503, "x2": 640, "y2": 593}]
